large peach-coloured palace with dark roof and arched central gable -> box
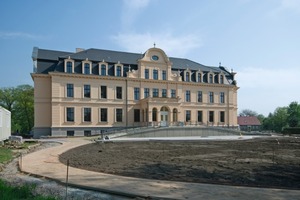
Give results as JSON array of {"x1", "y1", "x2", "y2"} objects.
[{"x1": 31, "y1": 47, "x2": 238, "y2": 137}]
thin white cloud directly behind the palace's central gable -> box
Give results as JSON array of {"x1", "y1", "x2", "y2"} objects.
[{"x1": 112, "y1": 32, "x2": 202, "y2": 57}]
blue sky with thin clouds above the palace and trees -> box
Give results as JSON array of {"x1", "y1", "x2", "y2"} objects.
[{"x1": 0, "y1": 0, "x2": 300, "y2": 115}]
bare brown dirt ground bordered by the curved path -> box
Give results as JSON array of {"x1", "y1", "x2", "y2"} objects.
[{"x1": 60, "y1": 137, "x2": 300, "y2": 189}]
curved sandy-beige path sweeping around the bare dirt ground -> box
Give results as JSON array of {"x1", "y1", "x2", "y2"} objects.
[{"x1": 21, "y1": 138, "x2": 300, "y2": 200}]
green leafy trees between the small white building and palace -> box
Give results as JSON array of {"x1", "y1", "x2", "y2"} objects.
[{"x1": 0, "y1": 85, "x2": 34, "y2": 133}]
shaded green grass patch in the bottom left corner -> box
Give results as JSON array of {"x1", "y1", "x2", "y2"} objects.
[{"x1": 0, "y1": 179, "x2": 56, "y2": 200}]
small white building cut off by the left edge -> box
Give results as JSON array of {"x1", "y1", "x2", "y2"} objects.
[{"x1": 0, "y1": 106, "x2": 11, "y2": 141}]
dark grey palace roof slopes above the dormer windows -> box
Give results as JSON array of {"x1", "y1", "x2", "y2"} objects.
[{"x1": 34, "y1": 47, "x2": 230, "y2": 75}]
